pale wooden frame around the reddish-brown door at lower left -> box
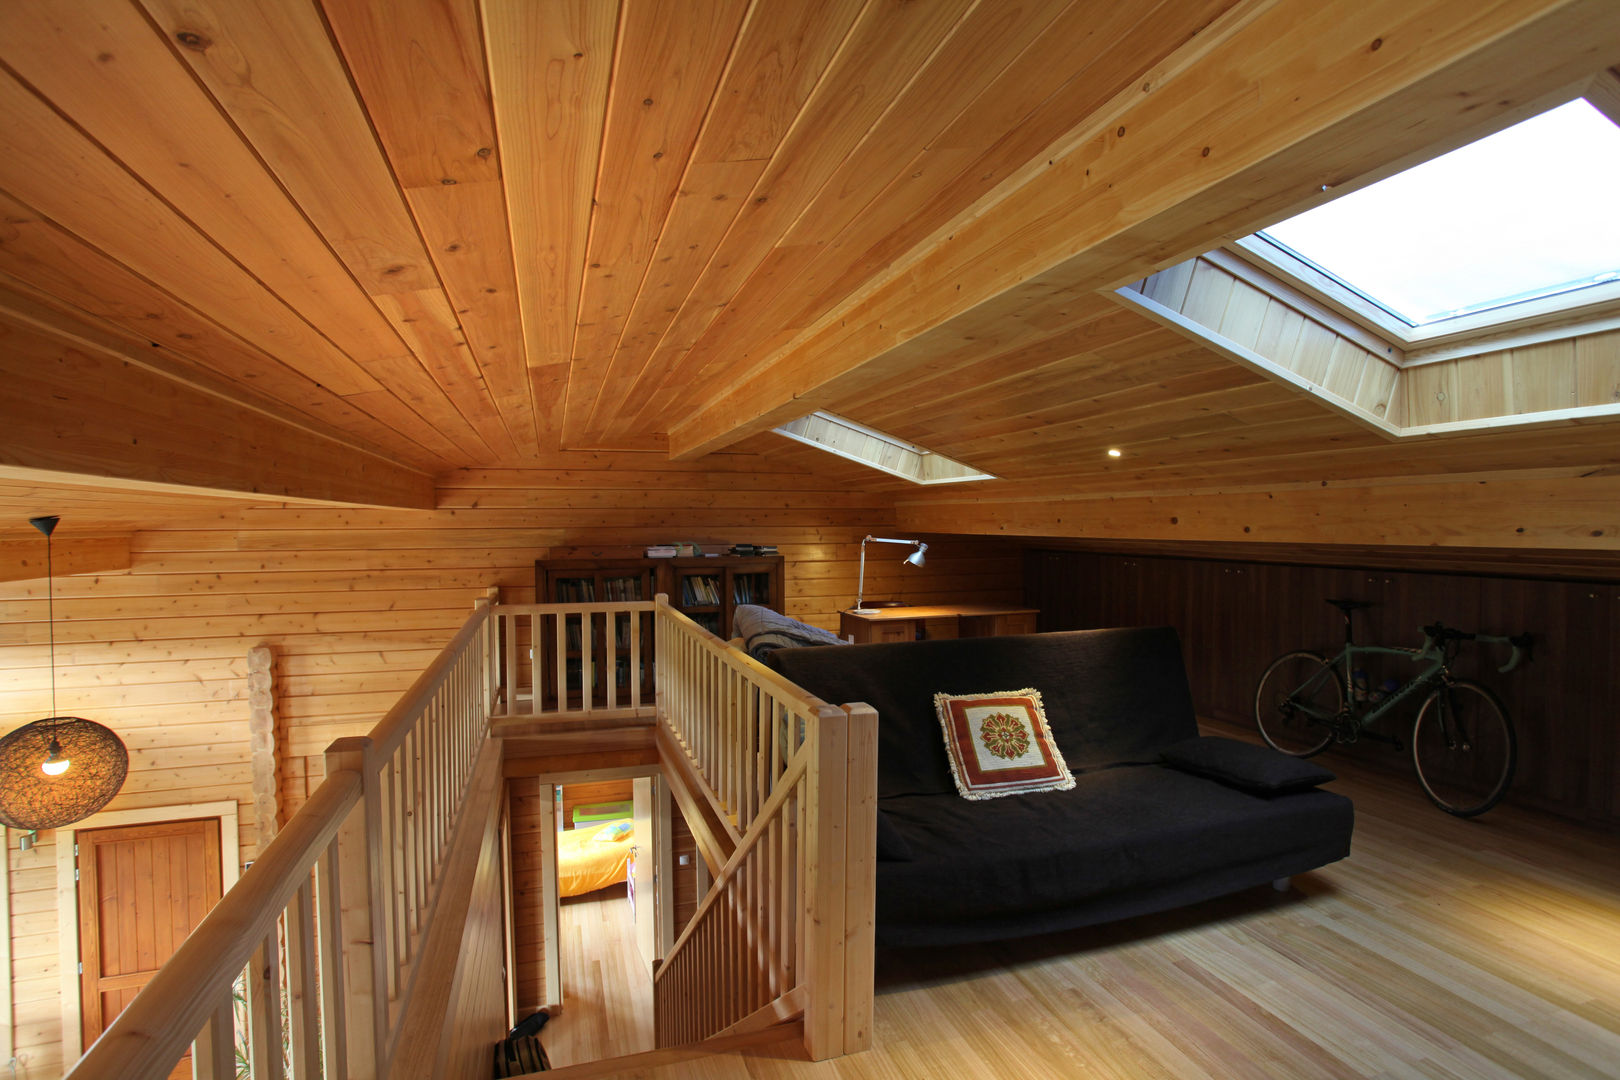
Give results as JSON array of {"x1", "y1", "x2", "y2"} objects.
[{"x1": 57, "y1": 800, "x2": 241, "y2": 1069}]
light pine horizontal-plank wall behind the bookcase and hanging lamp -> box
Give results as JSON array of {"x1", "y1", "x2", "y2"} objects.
[{"x1": 0, "y1": 450, "x2": 1021, "y2": 1080}]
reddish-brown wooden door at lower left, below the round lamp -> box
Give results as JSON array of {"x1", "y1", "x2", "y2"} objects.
[{"x1": 78, "y1": 818, "x2": 222, "y2": 1077}]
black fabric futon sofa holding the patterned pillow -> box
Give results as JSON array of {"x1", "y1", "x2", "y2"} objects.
[{"x1": 766, "y1": 627, "x2": 1353, "y2": 946}]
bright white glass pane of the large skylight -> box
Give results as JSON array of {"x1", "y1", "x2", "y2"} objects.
[{"x1": 1260, "y1": 99, "x2": 1620, "y2": 325}]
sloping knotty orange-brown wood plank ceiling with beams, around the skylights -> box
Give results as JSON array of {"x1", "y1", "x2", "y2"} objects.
[{"x1": 0, "y1": 0, "x2": 1620, "y2": 537}]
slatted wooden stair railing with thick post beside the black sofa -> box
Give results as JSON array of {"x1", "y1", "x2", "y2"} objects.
[{"x1": 654, "y1": 597, "x2": 876, "y2": 1059}]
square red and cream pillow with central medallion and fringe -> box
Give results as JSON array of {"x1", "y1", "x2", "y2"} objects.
[{"x1": 933, "y1": 690, "x2": 1074, "y2": 800}]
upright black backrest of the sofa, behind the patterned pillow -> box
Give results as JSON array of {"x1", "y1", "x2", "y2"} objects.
[{"x1": 765, "y1": 627, "x2": 1199, "y2": 798}]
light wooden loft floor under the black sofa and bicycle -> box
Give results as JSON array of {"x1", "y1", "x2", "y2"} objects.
[{"x1": 596, "y1": 735, "x2": 1620, "y2": 1080}]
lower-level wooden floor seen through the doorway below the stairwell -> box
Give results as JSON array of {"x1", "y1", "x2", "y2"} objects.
[{"x1": 541, "y1": 884, "x2": 653, "y2": 1067}]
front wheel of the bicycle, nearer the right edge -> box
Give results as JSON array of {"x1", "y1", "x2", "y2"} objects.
[{"x1": 1413, "y1": 680, "x2": 1518, "y2": 818}]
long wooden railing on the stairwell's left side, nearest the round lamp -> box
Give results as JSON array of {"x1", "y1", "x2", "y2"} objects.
[{"x1": 68, "y1": 601, "x2": 499, "y2": 1080}]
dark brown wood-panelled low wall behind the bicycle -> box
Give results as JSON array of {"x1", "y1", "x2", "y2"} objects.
[{"x1": 1025, "y1": 549, "x2": 1620, "y2": 826}]
